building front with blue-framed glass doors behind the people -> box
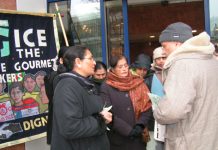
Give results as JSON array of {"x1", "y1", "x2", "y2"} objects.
[{"x1": 0, "y1": 0, "x2": 218, "y2": 150}]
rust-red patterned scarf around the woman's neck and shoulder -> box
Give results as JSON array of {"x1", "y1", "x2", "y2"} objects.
[{"x1": 106, "y1": 70, "x2": 151, "y2": 120}]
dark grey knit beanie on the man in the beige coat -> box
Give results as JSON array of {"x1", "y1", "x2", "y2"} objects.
[{"x1": 159, "y1": 22, "x2": 193, "y2": 43}]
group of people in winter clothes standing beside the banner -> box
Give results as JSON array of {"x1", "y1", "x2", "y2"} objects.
[{"x1": 42, "y1": 22, "x2": 218, "y2": 150}]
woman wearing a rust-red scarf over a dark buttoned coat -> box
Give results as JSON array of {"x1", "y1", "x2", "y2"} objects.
[{"x1": 101, "y1": 56, "x2": 152, "y2": 150}]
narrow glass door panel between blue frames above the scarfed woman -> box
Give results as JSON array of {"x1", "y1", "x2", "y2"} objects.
[{"x1": 104, "y1": 0, "x2": 129, "y2": 65}]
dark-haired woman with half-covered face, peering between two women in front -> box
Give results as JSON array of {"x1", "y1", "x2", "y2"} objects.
[{"x1": 91, "y1": 61, "x2": 107, "y2": 93}]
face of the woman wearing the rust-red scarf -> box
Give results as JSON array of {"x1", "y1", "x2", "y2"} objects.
[{"x1": 113, "y1": 58, "x2": 129, "y2": 77}]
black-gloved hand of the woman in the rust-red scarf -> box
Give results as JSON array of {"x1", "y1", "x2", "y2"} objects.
[{"x1": 128, "y1": 124, "x2": 145, "y2": 139}]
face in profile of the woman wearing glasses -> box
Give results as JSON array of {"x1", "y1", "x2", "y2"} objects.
[{"x1": 75, "y1": 50, "x2": 96, "y2": 77}]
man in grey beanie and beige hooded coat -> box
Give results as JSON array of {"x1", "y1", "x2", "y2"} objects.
[{"x1": 154, "y1": 22, "x2": 218, "y2": 150}]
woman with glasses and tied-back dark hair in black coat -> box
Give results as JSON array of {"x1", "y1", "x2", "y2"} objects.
[{"x1": 51, "y1": 46, "x2": 112, "y2": 150}]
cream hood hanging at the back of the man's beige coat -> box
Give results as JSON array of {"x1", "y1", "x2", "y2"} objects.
[{"x1": 164, "y1": 32, "x2": 215, "y2": 70}]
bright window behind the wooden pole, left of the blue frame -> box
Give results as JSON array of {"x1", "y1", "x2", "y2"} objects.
[{"x1": 49, "y1": 0, "x2": 102, "y2": 60}]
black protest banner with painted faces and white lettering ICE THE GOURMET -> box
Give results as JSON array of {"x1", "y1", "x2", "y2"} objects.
[{"x1": 0, "y1": 11, "x2": 57, "y2": 148}]
